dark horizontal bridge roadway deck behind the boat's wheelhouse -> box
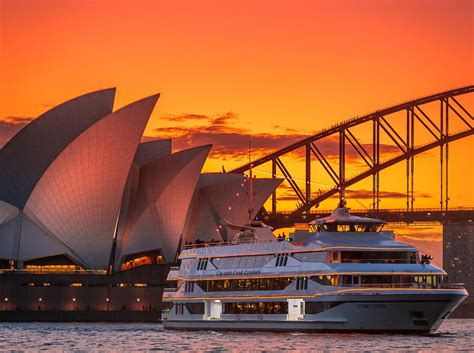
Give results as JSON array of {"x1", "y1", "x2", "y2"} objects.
[{"x1": 262, "y1": 207, "x2": 474, "y2": 228}]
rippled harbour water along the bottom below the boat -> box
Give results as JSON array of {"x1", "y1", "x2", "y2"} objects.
[{"x1": 0, "y1": 319, "x2": 474, "y2": 352}]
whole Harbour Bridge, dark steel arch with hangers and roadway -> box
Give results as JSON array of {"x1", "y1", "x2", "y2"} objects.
[{"x1": 231, "y1": 85, "x2": 474, "y2": 228}]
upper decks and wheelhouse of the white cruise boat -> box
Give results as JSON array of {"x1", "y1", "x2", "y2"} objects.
[{"x1": 170, "y1": 207, "x2": 445, "y2": 278}]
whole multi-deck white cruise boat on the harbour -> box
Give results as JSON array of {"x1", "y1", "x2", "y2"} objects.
[{"x1": 163, "y1": 203, "x2": 467, "y2": 333}]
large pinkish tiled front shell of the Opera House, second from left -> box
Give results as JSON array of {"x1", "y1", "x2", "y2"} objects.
[{"x1": 25, "y1": 95, "x2": 159, "y2": 269}]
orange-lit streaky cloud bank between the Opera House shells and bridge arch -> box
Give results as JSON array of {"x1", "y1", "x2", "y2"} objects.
[{"x1": 144, "y1": 112, "x2": 400, "y2": 167}]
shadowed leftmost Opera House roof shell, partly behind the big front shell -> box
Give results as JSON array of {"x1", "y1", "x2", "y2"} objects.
[{"x1": 0, "y1": 88, "x2": 115, "y2": 209}]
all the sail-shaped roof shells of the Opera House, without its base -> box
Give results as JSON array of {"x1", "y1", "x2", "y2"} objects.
[{"x1": 0, "y1": 89, "x2": 281, "y2": 271}]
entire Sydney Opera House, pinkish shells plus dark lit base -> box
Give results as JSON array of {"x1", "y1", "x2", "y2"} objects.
[{"x1": 0, "y1": 89, "x2": 281, "y2": 321}]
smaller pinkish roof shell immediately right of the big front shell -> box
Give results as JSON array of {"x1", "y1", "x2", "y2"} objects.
[{"x1": 117, "y1": 146, "x2": 211, "y2": 261}]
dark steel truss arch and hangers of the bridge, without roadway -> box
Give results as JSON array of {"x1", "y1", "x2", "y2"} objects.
[{"x1": 231, "y1": 85, "x2": 474, "y2": 215}]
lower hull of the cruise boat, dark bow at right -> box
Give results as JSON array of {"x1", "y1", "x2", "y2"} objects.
[{"x1": 163, "y1": 290, "x2": 467, "y2": 333}]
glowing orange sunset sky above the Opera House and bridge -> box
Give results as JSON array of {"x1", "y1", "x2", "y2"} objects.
[{"x1": 0, "y1": 0, "x2": 474, "y2": 262}]
